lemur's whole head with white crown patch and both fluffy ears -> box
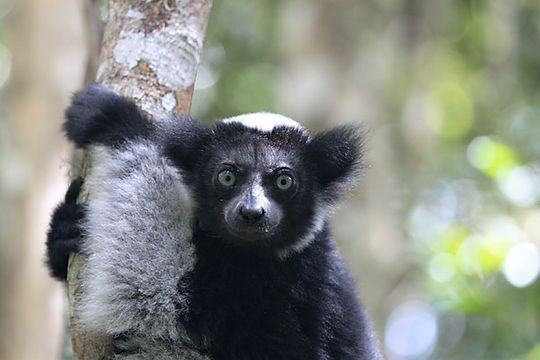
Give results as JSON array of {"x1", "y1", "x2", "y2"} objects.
[{"x1": 161, "y1": 113, "x2": 361, "y2": 257}]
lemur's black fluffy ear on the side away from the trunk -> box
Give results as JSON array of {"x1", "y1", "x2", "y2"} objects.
[{"x1": 306, "y1": 126, "x2": 363, "y2": 188}]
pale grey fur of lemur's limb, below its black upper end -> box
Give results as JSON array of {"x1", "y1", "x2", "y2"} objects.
[{"x1": 78, "y1": 140, "x2": 206, "y2": 360}]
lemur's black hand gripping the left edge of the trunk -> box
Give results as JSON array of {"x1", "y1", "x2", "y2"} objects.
[{"x1": 47, "y1": 177, "x2": 86, "y2": 281}]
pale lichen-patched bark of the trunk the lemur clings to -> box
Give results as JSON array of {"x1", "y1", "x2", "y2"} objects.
[{"x1": 68, "y1": 0, "x2": 212, "y2": 360}]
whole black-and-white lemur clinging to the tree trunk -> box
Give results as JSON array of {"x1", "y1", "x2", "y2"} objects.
[{"x1": 47, "y1": 85, "x2": 382, "y2": 360}]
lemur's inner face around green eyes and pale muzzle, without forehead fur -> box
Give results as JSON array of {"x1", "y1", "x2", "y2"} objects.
[{"x1": 210, "y1": 143, "x2": 301, "y2": 242}]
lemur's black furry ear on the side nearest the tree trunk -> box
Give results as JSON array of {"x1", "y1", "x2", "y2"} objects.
[{"x1": 162, "y1": 118, "x2": 212, "y2": 171}]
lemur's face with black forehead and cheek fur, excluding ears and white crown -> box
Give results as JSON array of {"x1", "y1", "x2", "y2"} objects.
[{"x1": 197, "y1": 124, "x2": 314, "y2": 248}]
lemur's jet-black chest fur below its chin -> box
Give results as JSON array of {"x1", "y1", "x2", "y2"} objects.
[{"x1": 184, "y1": 236, "x2": 320, "y2": 359}]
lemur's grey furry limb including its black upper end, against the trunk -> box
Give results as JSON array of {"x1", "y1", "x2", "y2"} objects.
[{"x1": 49, "y1": 85, "x2": 195, "y2": 339}]
